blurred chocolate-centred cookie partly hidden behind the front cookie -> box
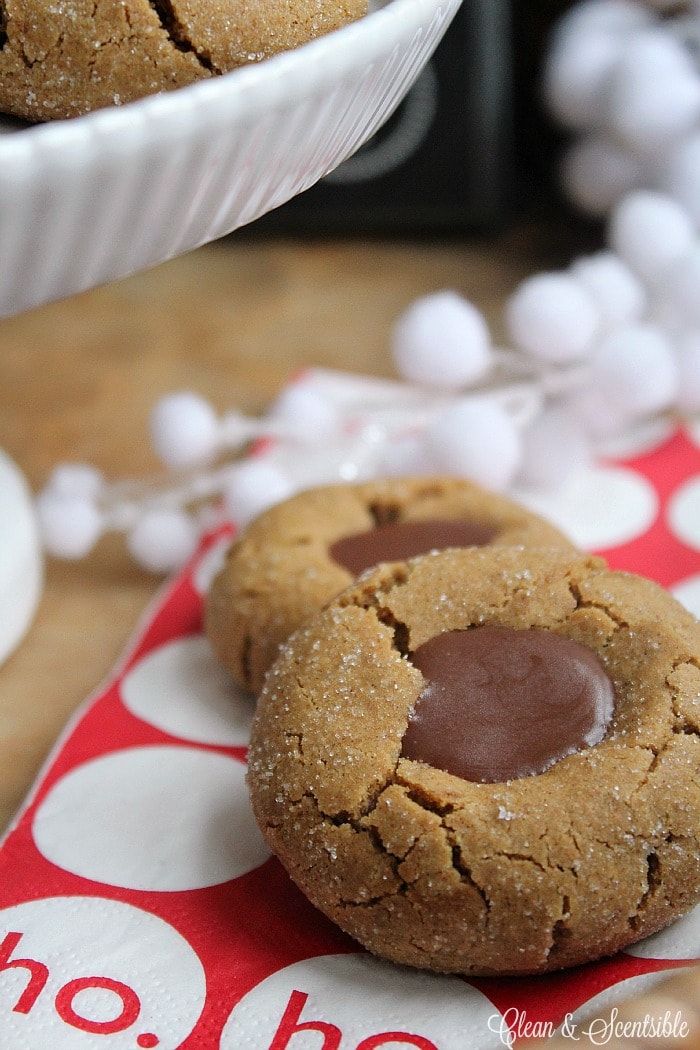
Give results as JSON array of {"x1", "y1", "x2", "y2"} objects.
[{"x1": 206, "y1": 478, "x2": 571, "y2": 692}]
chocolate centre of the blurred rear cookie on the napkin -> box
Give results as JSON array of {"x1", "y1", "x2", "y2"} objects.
[{"x1": 328, "y1": 519, "x2": 495, "y2": 576}]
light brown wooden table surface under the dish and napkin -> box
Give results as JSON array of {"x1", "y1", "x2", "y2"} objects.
[{"x1": 0, "y1": 225, "x2": 571, "y2": 827}]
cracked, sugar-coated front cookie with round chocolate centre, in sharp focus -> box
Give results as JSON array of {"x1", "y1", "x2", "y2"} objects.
[{"x1": 249, "y1": 547, "x2": 700, "y2": 974}]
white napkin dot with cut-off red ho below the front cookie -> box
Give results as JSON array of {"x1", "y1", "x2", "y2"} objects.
[{"x1": 220, "y1": 953, "x2": 507, "y2": 1050}]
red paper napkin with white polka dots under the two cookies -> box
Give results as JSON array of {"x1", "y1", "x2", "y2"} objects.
[{"x1": 0, "y1": 373, "x2": 700, "y2": 1050}]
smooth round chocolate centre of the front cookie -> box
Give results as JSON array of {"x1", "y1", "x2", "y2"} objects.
[{"x1": 402, "y1": 627, "x2": 615, "y2": 783}]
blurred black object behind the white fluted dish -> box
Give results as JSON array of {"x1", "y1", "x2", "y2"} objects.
[{"x1": 248, "y1": 0, "x2": 571, "y2": 236}]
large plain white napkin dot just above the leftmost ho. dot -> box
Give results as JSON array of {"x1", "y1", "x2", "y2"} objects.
[{"x1": 33, "y1": 747, "x2": 269, "y2": 890}]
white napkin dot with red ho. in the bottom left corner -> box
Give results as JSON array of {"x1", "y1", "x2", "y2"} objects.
[{"x1": 0, "y1": 897, "x2": 207, "y2": 1050}]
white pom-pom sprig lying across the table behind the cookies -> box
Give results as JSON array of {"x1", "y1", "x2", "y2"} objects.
[{"x1": 37, "y1": 191, "x2": 700, "y2": 572}]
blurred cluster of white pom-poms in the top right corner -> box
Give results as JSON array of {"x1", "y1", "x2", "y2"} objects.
[{"x1": 543, "y1": 0, "x2": 700, "y2": 225}]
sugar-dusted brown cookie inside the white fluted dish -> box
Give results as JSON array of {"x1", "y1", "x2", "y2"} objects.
[{"x1": 0, "y1": 0, "x2": 367, "y2": 121}]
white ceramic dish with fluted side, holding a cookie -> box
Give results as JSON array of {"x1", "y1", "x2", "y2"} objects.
[{"x1": 0, "y1": 0, "x2": 460, "y2": 317}]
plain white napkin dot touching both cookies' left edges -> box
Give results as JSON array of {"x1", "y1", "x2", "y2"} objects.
[{"x1": 121, "y1": 634, "x2": 254, "y2": 747}]
